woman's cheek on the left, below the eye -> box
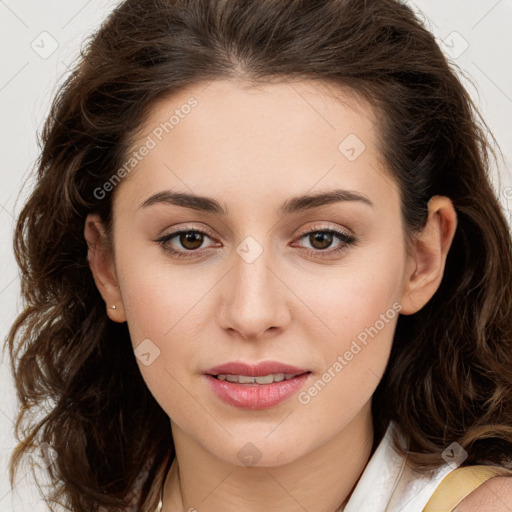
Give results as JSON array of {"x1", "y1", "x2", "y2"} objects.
[{"x1": 117, "y1": 251, "x2": 212, "y2": 416}]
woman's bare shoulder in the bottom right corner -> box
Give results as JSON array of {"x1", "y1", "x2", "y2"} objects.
[{"x1": 454, "y1": 476, "x2": 512, "y2": 512}]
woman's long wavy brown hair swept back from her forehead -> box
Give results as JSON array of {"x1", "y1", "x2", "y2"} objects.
[{"x1": 7, "y1": 0, "x2": 512, "y2": 512}]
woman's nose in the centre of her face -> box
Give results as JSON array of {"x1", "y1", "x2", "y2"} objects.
[{"x1": 218, "y1": 241, "x2": 290, "y2": 341}]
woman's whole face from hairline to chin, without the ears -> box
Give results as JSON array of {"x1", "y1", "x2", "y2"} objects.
[{"x1": 91, "y1": 81, "x2": 428, "y2": 465}]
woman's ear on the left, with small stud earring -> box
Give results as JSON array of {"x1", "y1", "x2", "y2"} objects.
[{"x1": 84, "y1": 213, "x2": 126, "y2": 322}]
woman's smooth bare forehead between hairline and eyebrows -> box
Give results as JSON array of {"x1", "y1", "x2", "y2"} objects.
[{"x1": 113, "y1": 80, "x2": 396, "y2": 211}]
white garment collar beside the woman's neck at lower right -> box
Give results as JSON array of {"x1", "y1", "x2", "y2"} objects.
[{"x1": 339, "y1": 422, "x2": 455, "y2": 512}]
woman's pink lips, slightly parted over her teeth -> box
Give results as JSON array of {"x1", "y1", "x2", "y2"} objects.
[{"x1": 205, "y1": 361, "x2": 311, "y2": 409}]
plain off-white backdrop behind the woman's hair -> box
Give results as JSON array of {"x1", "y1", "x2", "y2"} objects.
[{"x1": 0, "y1": 0, "x2": 512, "y2": 512}]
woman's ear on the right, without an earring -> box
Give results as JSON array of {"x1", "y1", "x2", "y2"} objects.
[{"x1": 400, "y1": 196, "x2": 457, "y2": 315}]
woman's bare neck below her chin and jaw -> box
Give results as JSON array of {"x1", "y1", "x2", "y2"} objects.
[{"x1": 162, "y1": 401, "x2": 374, "y2": 512}]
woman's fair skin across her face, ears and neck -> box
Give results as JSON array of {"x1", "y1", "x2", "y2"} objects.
[{"x1": 85, "y1": 81, "x2": 457, "y2": 512}]
